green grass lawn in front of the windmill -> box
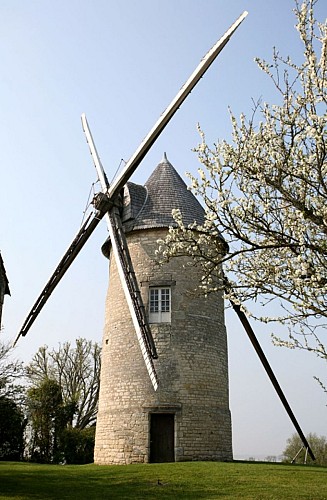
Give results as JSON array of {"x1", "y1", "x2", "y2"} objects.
[{"x1": 0, "y1": 462, "x2": 327, "y2": 500}]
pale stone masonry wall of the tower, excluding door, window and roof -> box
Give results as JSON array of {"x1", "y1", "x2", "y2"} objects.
[{"x1": 95, "y1": 229, "x2": 232, "y2": 464}]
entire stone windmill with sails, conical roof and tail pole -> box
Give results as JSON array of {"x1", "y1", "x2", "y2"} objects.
[{"x1": 14, "y1": 11, "x2": 314, "y2": 464}]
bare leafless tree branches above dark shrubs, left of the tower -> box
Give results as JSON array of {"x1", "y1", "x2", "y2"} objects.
[{"x1": 26, "y1": 339, "x2": 101, "y2": 429}]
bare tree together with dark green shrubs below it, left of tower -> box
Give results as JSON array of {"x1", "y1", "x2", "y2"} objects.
[{"x1": 25, "y1": 339, "x2": 101, "y2": 463}]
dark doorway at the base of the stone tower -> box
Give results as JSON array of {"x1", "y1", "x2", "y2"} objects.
[{"x1": 150, "y1": 413, "x2": 175, "y2": 463}]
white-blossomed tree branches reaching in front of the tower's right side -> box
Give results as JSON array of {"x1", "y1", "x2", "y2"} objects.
[{"x1": 159, "y1": 0, "x2": 327, "y2": 358}]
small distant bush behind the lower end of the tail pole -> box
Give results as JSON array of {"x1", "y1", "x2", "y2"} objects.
[{"x1": 283, "y1": 433, "x2": 327, "y2": 465}]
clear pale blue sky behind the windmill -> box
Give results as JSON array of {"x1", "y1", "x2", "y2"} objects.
[{"x1": 0, "y1": 0, "x2": 327, "y2": 458}]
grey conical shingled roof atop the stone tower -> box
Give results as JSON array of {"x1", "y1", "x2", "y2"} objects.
[{"x1": 123, "y1": 153, "x2": 204, "y2": 230}]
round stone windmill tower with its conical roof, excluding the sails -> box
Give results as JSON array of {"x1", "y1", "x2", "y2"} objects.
[{"x1": 95, "y1": 155, "x2": 232, "y2": 464}]
